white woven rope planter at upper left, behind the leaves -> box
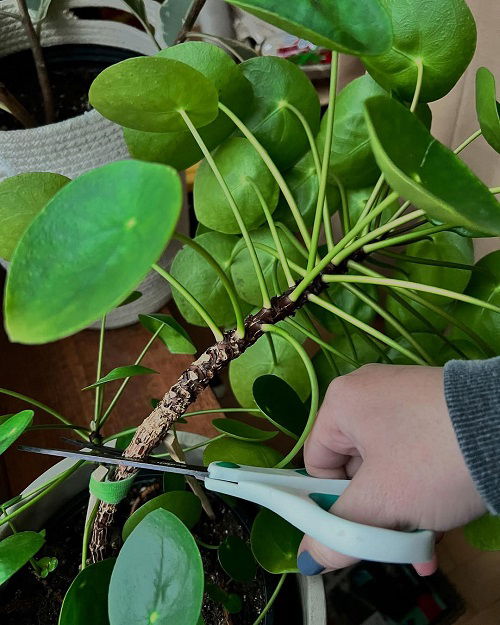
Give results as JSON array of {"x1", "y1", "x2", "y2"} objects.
[{"x1": 0, "y1": 0, "x2": 189, "y2": 328}]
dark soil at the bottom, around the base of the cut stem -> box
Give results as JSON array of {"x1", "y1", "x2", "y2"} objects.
[{"x1": 0, "y1": 478, "x2": 272, "y2": 625}]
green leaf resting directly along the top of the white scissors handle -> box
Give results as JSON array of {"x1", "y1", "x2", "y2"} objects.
[{"x1": 203, "y1": 437, "x2": 283, "y2": 467}]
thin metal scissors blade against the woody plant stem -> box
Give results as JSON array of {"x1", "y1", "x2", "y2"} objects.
[{"x1": 19, "y1": 445, "x2": 208, "y2": 481}]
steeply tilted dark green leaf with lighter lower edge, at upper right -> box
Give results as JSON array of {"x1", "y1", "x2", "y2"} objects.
[{"x1": 366, "y1": 96, "x2": 500, "y2": 236}]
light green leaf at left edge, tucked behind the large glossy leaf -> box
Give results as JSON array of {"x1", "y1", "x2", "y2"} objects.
[{"x1": 0, "y1": 172, "x2": 69, "y2": 260}]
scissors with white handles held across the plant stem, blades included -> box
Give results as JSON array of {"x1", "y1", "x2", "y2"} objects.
[{"x1": 19, "y1": 439, "x2": 434, "y2": 564}]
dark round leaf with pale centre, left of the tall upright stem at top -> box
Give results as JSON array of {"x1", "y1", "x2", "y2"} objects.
[{"x1": 241, "y1": 56, "x2": 320, "y2": 170}]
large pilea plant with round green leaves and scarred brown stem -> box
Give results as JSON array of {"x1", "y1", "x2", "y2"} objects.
[{"x1": 0, "y1": 0, "x2": 500, "y2": 625}]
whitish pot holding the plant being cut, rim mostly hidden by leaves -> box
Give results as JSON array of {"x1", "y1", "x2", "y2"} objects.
[{"x1": 0, "y1": 432, "x2": 326, "y2": 625}]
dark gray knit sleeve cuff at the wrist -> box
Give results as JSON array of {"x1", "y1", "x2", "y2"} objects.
[{"x1": 444, "y1": 357, "x2": 500, "y2": 514}]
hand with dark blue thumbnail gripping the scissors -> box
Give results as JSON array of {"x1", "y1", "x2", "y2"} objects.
[{"x1": 298, "y1": 365, "x2": 486, "y2": 575}]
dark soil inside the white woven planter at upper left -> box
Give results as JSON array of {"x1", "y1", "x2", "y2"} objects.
[{"x1": 0, "y1": 44, "x2": 137, "y2": 130}]
